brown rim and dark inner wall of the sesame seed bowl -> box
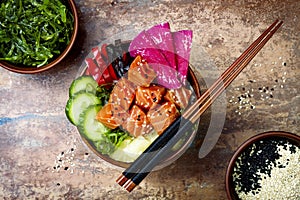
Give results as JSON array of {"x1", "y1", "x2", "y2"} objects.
[{"x1": 225, "y1": 131, "x2": 300, "y2": 200}]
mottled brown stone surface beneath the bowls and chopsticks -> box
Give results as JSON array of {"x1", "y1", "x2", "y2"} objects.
[{"x1": 0, "y1": 0, "x2": 300, "y2": 199}]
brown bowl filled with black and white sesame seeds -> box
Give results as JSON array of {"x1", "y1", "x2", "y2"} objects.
[{"x1": 225, "y1": 131, "x2": 300, "y2": 200}]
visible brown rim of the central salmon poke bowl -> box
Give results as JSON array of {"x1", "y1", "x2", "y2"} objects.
[{"x1": 77, "y1": 64, "x2": 201, "y2": 171}]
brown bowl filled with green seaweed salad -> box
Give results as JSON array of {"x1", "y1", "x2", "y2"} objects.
[{"x1": 0, "y1": 0, "x2": 78, "y2": 74}]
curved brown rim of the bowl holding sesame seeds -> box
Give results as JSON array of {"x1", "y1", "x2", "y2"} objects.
[{"x1": 225, "y1": 131, "x2": 300, "y2": 200}]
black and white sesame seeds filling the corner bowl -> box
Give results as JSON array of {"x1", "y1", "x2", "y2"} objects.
[{"x1": 233, "y1": 137, "x2": 300, "y2": 199}]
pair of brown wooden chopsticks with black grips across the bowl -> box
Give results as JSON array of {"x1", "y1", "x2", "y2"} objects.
[{"x1": 116, "y1": 20, "x2": 283, "y2": 192}]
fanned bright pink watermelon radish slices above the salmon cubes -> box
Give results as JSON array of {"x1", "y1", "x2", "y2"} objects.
[{"x1": 129, "y1": 22, "x2": 193, "y2": 89}]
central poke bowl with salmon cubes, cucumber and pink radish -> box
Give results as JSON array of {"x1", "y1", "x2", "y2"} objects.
[{"x1": 66, "y1": 23, "x2": 200, "y2": 170}]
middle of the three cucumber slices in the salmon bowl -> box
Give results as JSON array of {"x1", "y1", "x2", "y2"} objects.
[{"x1": 65, "y1": 92, "x2": 101, "y2": 126}]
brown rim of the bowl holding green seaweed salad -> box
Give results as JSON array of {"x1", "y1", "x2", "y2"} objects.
[{"x1": 0, "y1": 0, "x2": 79, "y2": 74}]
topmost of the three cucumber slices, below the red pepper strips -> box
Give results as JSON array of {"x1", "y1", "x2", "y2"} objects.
[{"x1": 69, "y1": 75, "x2": 98, "y2": 97}]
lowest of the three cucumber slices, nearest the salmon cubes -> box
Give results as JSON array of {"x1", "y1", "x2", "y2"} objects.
[{"x1": 78, "y1": 105, "x2": 110, "y2": 141}]
